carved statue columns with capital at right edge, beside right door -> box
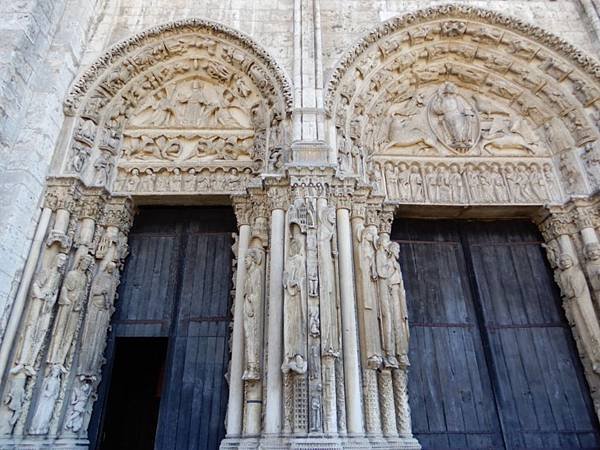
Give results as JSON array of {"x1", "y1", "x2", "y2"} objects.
[{"x1": 540, "y1": 205, "x2": 600, "y2": 417}]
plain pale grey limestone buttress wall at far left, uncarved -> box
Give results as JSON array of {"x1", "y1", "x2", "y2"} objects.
[{"x1": 0, "y1": 0, "x2": 104, "y2": 339}]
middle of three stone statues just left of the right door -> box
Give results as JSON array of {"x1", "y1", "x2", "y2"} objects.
[{"x1": 375, "y1": 233, "x2": 398, "y2": 367}]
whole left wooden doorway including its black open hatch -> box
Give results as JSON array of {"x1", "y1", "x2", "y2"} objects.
[{"x1": 90, "y1": 207, "x2": 235, "y2": 450}]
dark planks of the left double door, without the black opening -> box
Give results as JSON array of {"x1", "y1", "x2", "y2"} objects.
[{"x1": 99, "y1": 207, "x2": 235, "y2": 450}]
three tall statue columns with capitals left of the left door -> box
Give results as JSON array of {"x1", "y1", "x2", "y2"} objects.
[{"x1": 0, "y1": 178, "x2": 132, "y2": 436}]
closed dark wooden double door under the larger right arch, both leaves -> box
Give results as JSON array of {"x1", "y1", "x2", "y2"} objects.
[{"x1": 392, "y1": 220, "x2": 600, "y2": 449}]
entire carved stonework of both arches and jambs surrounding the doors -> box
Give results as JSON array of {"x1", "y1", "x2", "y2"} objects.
[{"x1": 0, "y1": 5, "x2": 600, "y2": 449}]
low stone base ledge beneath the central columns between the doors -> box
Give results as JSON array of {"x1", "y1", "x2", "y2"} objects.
[{"x1": 220, "y1": 436, "x2": 421, "y2": 450}]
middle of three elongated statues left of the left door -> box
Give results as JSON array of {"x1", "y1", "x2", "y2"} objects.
[{"x1": 48, "y1": 255, "x2": 93, "y2": 368}]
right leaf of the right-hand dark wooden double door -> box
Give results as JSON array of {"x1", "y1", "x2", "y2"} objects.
[{"x1": 467, "y1": 223, "x2": 600, "y2": 448}]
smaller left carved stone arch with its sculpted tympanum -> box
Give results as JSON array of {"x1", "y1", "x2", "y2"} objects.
[{"x1": 64, "y1": 20, "x2": 291, "y2": 194}]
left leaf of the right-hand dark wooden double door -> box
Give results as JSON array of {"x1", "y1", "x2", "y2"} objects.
[{"x1": 394, "y1": 223, "x2": 502, "y2": 448}]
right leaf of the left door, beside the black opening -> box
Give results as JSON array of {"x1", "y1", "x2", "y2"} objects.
[{"x1": 157, "y1": 229, "x2": 231, "y2": 450}]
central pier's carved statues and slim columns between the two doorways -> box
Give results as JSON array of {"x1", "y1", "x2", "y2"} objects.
[{"x1": 281, "y1": 169, "x2": 346, "y2": 434}]
